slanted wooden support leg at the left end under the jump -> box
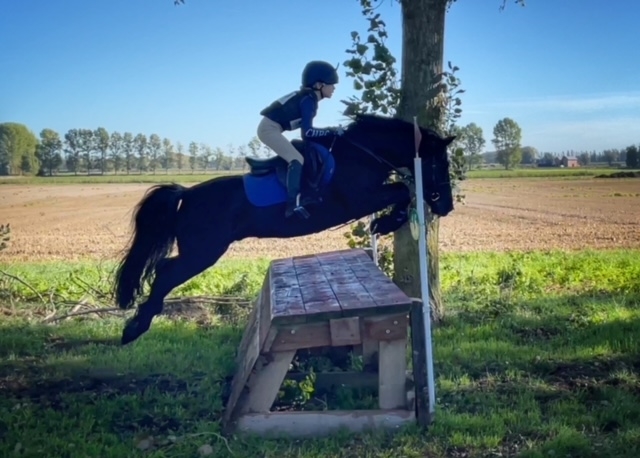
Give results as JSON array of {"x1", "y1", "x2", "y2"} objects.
[{"x1": 240, "y1": 350, "x2": 296, "y2": 414}]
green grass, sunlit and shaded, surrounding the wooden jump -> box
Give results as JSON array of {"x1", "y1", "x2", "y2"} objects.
[{"x1": 0, "y1": 250, "x2": 640, "y2": 458}]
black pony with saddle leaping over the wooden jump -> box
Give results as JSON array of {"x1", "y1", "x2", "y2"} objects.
[{"x1": 114, "y1": 115, "x2": 454, "y2": 345}]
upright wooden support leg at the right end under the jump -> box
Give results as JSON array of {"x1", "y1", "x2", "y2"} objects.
[{"x1": 378, "y1": 338, "x2": 407, "y2": 409}]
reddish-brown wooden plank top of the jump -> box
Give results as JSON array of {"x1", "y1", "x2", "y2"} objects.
[{"x1": 269, "y1": 249, "x2": 411, "y2": 324}]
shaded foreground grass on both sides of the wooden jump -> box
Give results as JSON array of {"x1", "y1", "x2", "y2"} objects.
[{"x1": 0, "y1": 295, "x2": 640, "y2": 458}]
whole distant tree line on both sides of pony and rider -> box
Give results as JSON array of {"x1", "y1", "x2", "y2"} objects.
[{"x1": 0, "y1": 118, "x2": 640, "y2": 176}]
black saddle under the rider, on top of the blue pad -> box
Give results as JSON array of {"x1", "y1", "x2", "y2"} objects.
[{"x1": 245, "y1": 139, "x2": 330, "y2": 192}]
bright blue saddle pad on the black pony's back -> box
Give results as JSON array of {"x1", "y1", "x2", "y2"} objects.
[{"x1": 242, "y1": 144, "x2": 335, "y2": 207}]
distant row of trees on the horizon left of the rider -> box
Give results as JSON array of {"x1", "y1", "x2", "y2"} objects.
[{"x1": 0, "y1": 122, "x2": 270, "y2": 176}]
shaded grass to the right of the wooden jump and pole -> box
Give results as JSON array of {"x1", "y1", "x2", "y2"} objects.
[{"x1": 434, "y1": 294, "x2": 640, "y2": 457}]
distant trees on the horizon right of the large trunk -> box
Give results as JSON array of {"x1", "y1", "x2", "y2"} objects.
[{"x1": 454, "y1": 118, "x2": 640, "y2": 169}]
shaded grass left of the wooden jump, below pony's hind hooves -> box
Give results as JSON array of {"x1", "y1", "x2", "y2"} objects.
[{"x1": 0, "y1": 313, "x2": 256, "y2": 457}]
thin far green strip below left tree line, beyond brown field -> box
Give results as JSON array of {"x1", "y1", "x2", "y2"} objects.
[{"x1": 0, "y1": 171, "x2": 242, "y2": 185}]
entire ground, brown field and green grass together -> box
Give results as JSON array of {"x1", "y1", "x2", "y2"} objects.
[{"x1": 0, "y1": 171, "x2": 640, "y2": 458}]
